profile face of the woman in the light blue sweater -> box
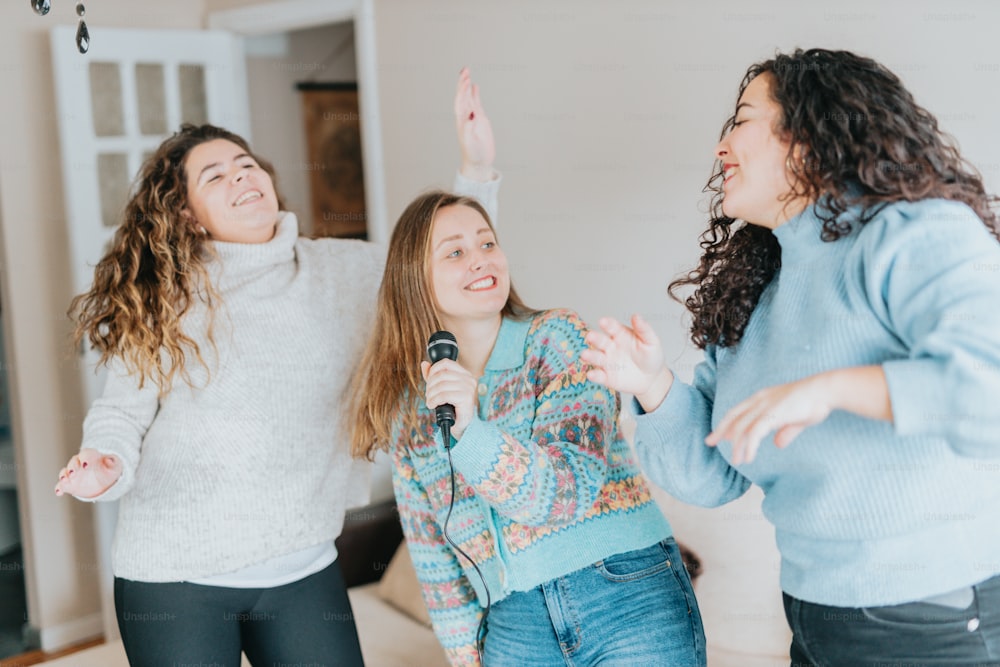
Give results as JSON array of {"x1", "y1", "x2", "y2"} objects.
[{"x1": 715, "y1": 74, "x2": 806, "y2": 229}]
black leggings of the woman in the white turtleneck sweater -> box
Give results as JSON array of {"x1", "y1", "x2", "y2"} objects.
[{"x1": 115, "y1": 562, "x2": 364, "y2": 667}]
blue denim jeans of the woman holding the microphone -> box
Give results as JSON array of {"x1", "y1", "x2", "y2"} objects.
[{"x1": 483, "y1": 538, "x2": 705, "y2": 667}]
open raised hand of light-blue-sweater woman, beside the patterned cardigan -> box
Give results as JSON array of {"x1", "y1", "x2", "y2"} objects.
[{"x1": 581, "y1": 315, "x2": 674, "y2": 412}]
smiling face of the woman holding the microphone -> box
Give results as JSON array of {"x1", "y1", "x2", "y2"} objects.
[{"x1": 429, "y1": 205, "x2": 510, "y2": 329}]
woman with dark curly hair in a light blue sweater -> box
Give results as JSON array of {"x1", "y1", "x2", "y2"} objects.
[{"x1": 585, "y1": 49, "x2": 1000, "y2": 665}]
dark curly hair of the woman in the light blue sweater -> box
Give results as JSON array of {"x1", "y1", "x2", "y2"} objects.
[{"x1": 669, "y1": 49, "x2": 1000, "y2": 348}]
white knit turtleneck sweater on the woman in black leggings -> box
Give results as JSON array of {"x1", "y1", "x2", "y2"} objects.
[{"x1": 82, "y1": 213, "x2": 384, "y2": 582}]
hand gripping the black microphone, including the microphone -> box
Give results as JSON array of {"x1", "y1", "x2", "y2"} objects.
[{"x1": 420, "y1": 331, "x2": 477, "y2": 447}]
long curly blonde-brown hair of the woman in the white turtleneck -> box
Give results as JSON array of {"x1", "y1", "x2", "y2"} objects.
[{"x1": 68, "y1": 123, "x2": 284, "y2": 396}]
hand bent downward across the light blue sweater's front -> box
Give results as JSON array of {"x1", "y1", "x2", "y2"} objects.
[{"x1": 705, "y1": 374, "x2": 834, "y2": 465}]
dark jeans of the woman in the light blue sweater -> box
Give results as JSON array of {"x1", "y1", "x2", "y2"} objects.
[{"x1": 784, "y1": 576, "x2": 1000, "y2": 667}]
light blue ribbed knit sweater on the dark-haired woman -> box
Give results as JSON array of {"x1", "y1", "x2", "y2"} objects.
[{"x1": 636, "y1": 200, "x2": 1000, "y2": 607}]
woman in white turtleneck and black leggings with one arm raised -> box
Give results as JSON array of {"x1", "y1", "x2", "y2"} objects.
[{"x1": 56, "y1": 69, "x2": 494, "y2": 667}]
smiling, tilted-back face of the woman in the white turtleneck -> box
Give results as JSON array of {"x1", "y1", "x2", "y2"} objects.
[{"x1": 184, "y1": 139, "x2": 278, "y2": 243}]
